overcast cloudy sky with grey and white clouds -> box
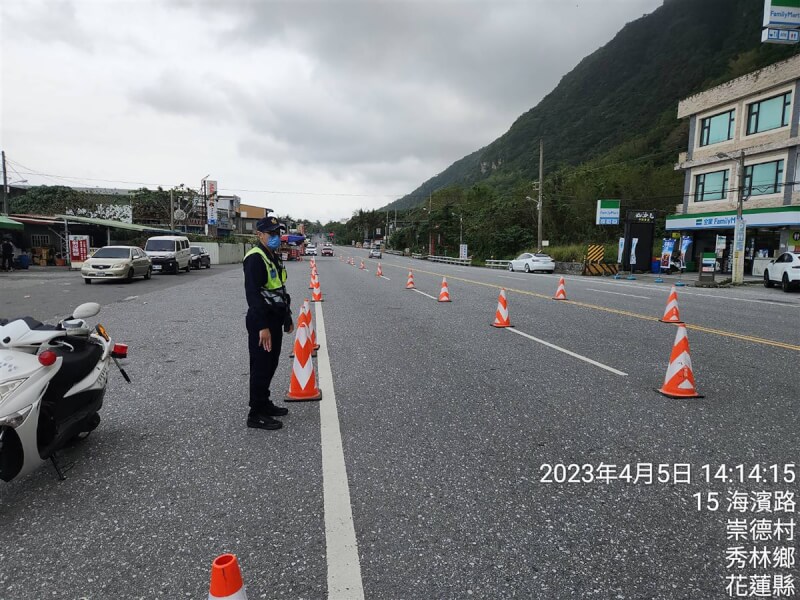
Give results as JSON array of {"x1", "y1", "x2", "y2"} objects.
[{"x1": 0, "y1": 0, "x2": 661, "y2": 223}]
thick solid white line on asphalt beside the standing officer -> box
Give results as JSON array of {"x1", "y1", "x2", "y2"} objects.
[{"x1": 314, "y1": 302, "x2": 364, "y2": 600}]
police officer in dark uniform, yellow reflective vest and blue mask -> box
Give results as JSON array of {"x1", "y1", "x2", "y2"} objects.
[{"x1": 244, "y1": 217, "x2": 294, "y2": 429}]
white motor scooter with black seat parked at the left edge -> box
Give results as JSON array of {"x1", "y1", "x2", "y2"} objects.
[{"x1": 0, "y1": 302, "x2": 130, "y2": 481}]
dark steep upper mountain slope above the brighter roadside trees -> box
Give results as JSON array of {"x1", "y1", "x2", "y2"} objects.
[{"x1": 386, "y1": 0, "x2": 798, "y2": 209}]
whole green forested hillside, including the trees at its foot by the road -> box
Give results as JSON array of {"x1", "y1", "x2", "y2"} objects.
[{"x1": 374, "y1": 0, "x2": 798, "y2": 256}]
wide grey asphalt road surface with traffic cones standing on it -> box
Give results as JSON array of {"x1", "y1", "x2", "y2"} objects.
[{"x1": 0, "y1": 248, "x2": 800, "y2": 599}]
